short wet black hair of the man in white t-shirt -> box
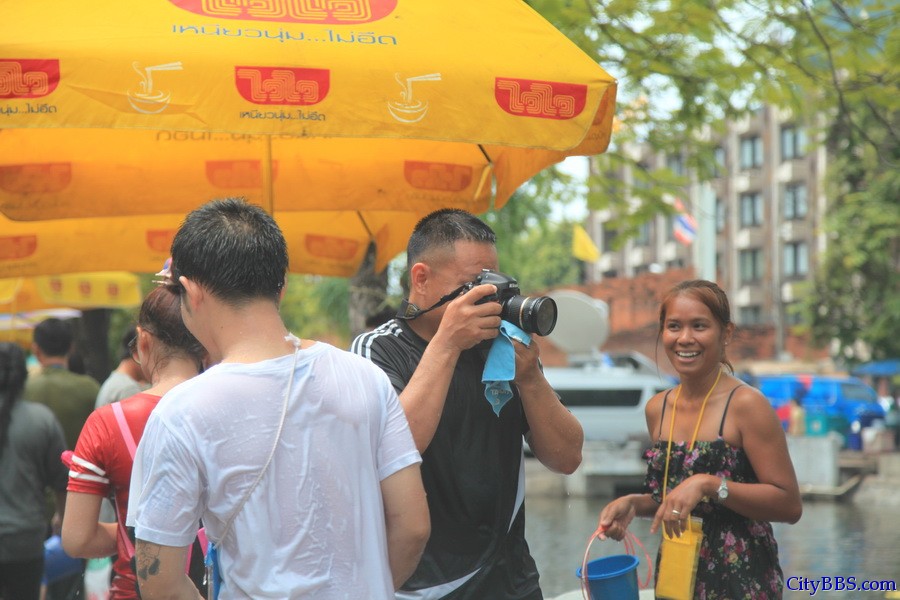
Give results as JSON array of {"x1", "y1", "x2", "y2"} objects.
[{"x1": 172, "y1": 198, "x2": 288, "y2": 304}]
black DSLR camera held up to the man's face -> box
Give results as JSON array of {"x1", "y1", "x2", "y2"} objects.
[{"x1": 465, "y1": 269, "x2": 557, "y2": 336}]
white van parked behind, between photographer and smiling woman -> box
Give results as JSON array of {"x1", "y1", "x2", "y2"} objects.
[{"x1": 544, "y1": 356, "x2": 672, "y2": 443}]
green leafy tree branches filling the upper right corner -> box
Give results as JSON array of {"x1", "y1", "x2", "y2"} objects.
[{"x1": 529, "y1": 0, "x2": 900, "y2": 360}]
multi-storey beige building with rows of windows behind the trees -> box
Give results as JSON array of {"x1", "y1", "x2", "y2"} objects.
[{"x1": 572, "y1": 106, "x2": 827, "y2": 370}]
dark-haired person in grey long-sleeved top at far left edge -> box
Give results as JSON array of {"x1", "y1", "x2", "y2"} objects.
[{"x1": 0, "y1": 342, "x2": 66, "y2": 600}]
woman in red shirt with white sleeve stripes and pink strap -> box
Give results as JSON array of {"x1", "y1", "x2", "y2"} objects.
[{"x1": 62, "y1": 286, "x2": 205, "y2": 600}]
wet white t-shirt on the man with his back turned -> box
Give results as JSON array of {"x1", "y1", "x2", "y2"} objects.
[{"x1": 128, "y1": 342, "x2": 421, "y2": 600}]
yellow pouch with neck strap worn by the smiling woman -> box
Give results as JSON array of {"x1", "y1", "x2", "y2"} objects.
[{"x1": 656, "y1": 370, "x2": 722, "y2": 600}]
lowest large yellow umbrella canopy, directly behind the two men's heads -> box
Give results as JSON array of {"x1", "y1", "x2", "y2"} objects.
[{"x1": 0, "y1": 211, "x2": 419, "y2": 277}]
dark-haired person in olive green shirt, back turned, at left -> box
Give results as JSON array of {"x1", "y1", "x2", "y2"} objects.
[{"x1": 25, "y1": 317, "x2": 100, "y2": 450}]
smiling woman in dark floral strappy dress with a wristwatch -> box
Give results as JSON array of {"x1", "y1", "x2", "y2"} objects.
[{"x1": 600, "y1": 280, "x2": 802, "y2": 600}]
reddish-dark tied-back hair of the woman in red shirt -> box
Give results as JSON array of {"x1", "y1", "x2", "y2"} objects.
[{"x1": 137, "y1": 286, "x2": 206, "y2": 371}]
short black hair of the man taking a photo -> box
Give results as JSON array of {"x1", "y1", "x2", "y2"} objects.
[{"x1": 406, "y1": 208, "x2": 497, "y2": 269}]
